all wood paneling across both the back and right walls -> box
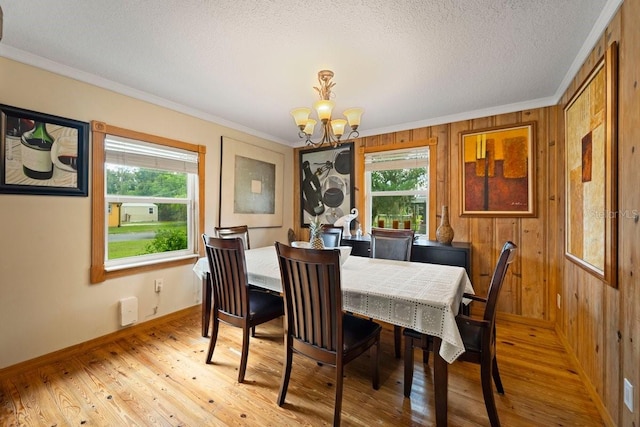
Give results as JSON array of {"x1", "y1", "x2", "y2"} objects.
[{"x1": 294, "y1": 0, "x2": 640, "y2": 426}]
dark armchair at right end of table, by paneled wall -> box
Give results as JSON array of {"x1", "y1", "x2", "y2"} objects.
[{"x1": 404, "y1": 241, "x2": 517, "y2": 427}]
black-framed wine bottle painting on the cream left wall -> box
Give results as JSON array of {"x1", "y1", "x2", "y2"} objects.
[{"x1": 0, "y1": 105, "x2": 89, "y2": 197}]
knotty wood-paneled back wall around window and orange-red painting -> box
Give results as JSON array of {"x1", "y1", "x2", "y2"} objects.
[{"x1": 294, "y1": 107, "x2": 558, "y2": 321}]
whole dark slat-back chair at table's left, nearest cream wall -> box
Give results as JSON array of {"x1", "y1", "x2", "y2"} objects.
[{"x1": 202, "y1": 234, "x2": 284, "y2": 383}]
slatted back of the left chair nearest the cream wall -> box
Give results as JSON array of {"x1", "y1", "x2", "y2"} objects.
[{"x1": 202, "y1": 235, "x2": 249, "y2": 318}]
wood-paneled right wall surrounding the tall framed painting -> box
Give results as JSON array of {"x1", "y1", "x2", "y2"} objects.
[{"x1": 556, "y1": 0, "x2": 640, "y2": 426}]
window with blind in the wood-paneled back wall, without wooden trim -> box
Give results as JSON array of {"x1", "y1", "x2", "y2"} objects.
[{"x1": 365, "y1": 147, "x2": 430, "y2": 235}]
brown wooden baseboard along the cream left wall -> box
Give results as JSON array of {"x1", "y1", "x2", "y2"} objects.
[{"x1": 0, "y1": 304, "x2": 200, "y2": 380}]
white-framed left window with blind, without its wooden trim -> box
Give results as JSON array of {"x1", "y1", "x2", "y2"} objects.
[{"x1": 104, "y1": 135, "x2": 198, "y2": 270}]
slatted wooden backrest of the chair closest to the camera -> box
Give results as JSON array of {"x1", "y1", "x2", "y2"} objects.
[{"x1": 276, "y1": 243, "x2": 342, "y2": 352}]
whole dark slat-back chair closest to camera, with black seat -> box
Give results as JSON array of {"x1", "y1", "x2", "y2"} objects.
[{"x1": 276, "y1": 243, "x2": 382, "y2": 426}]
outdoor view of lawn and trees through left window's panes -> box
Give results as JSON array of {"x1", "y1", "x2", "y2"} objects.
[{"x1": 106, "y1": 164, "x2": 189, "y2": 260}]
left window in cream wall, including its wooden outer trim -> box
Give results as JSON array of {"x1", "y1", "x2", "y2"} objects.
[{"x1": 91, "y1": 122, "x2": 205, "y2": 283}]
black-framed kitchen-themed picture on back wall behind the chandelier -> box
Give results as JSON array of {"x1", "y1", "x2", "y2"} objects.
[{"x1": 298, "y1": 142, "x2": 355, "y2": 227}]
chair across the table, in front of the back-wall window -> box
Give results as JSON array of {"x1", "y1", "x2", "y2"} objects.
[{"x1": 371, "y1": 228, "x2": 415, "y2": 359}]
